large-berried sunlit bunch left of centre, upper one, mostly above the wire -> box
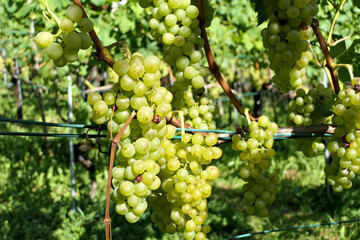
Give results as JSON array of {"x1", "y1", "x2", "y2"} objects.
[{"x1": 88, "y1": 52, "x2": 173, "y2": 125}]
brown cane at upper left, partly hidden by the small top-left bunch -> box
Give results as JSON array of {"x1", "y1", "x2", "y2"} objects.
[{"x1": 73, "y1": 0, "x2": 114, "y2": 68}]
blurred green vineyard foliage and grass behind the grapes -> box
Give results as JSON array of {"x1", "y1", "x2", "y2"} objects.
[{"x1": 0, "y1": 0, "x2": 360, "y2": 240}]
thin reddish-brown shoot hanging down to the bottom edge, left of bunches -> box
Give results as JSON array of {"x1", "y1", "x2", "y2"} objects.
[{"x1": 102, "y1": 111, "x2": 136, "y2": 240}]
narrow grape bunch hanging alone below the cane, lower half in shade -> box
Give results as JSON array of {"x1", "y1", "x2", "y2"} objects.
[{"x1": 232, "y1": 116, "x2": 279, "y2": 217}]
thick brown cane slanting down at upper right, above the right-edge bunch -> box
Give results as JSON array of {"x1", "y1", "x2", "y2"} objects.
[{"x1": 311, "y1": 18, "x2": 340, "y2": 94}]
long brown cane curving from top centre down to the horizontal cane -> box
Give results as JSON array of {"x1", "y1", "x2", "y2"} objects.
[{"x1": 197, "y1": 0, "x2": 255, "y2": 120}]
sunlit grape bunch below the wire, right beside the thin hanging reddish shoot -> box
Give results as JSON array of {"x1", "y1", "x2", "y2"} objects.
[{"x1": 111, "y1": 122, "x2": 176, "y2": 223}]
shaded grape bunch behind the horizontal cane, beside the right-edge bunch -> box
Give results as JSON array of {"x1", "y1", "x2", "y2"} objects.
[{"x1": 289, "y1": 84, "x2": 334, "y2": 157}]
